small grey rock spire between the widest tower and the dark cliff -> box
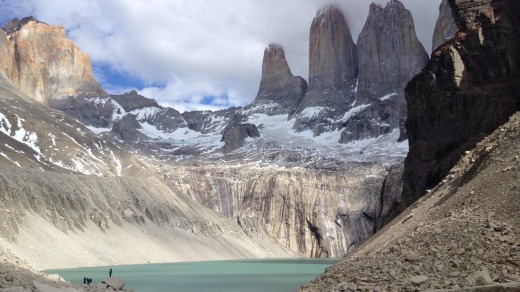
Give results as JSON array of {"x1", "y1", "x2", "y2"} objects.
[{"x1": 432, "y1": 0, "x2": 459, "y2": 51}]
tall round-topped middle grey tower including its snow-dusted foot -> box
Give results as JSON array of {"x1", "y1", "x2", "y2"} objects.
[{"x1": 294, "y1": 6, "x2": 358, "y2": 134}]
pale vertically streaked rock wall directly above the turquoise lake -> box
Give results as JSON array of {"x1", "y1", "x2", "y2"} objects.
[{"x1": 165, "y1": 164, "x2": 395, "y2": 257}]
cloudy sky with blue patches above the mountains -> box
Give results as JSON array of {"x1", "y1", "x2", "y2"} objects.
[{"x1": 0, "y1": 0, "x2": 441, "y2": 111}]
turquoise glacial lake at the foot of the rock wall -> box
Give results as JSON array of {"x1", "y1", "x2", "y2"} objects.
[{"x1": 45, "y1": 259, "x2": 339, "y2": 292}]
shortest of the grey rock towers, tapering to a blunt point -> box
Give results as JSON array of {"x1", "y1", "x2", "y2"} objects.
[{"x1": 251, "y1": 44, "x2": 307, "y2": 115}]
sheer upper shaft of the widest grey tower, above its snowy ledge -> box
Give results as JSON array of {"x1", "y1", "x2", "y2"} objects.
[{"x1": 357, "y1": 0, "x2": 428, "y2": 105}]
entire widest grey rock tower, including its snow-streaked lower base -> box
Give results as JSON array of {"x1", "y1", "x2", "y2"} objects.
[{"x1": 340, "y1": 0, "x2": 428, "y2": 143}]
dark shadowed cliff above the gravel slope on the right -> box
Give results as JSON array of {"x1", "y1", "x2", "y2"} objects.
[{"x1": 403, "y1": 0, "x2": 520, "y2": 203}]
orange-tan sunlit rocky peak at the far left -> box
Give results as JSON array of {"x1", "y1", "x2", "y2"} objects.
[{"x1": 3, "y1": 17, "x2": 105, "y2": 103}]
